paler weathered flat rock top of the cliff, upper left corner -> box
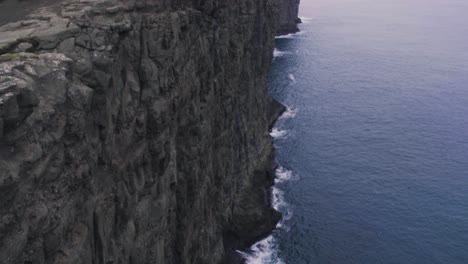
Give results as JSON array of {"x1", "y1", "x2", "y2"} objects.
[{"x1": 0, "y1": 0, "x2": 136, "y2": 54}]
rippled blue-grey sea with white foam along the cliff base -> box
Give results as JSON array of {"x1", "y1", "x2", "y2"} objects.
[{"x1": 244, "y1": 0, "x2": 468, "y2": 264}]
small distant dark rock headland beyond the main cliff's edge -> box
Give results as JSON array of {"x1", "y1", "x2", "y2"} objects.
[{"x1": 277, "y1": 0, "x2": 301, "y2": 35}]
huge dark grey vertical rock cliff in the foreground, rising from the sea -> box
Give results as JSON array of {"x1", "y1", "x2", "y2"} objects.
[{"x1": 0, "y1": 0, "x2": 282, "y2": 264}]
